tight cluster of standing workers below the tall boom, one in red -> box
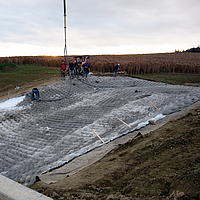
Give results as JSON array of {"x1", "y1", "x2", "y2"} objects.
[{"x1": 60, "y1": 60, "x2": 90, "y2": 80}]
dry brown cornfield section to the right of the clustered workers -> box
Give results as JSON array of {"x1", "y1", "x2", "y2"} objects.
[{"x1": 89, "y1": 53, "x2": 200, "y2": 74}]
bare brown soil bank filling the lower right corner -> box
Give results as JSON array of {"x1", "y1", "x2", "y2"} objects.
[{"x1": 31, "y1": 106, "x2": 200, "y2": 200}]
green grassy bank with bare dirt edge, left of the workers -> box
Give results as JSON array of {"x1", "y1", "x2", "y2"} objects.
[{"x1": 0, "y1": 63, "x2": 60, "y2": 100}]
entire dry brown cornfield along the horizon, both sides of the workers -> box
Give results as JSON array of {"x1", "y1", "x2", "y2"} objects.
[{"x1": 0, "y1": 52, "x2": 200, "y2": 74}]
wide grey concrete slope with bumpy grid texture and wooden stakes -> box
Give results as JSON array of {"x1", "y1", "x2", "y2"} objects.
[{"x1": 0, "y1": 76, "x2": 200, "y2": 186}]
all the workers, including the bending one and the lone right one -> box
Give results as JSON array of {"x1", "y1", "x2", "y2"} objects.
[{"x1": 31, "y1": 60, "x2": 120, "y2": 101}]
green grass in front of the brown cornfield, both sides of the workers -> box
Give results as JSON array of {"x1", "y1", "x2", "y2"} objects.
[{"x1": 0, "y1": 64, "x2": 200, "y2": 92}]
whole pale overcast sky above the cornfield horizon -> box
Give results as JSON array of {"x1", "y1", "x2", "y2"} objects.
[{"x1": 0, "y1": 0, "x2": 200, "y2": 56}]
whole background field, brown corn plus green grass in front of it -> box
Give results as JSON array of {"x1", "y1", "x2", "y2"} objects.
[{"x1": 0, "y1": 53, "x2": 200, "y2": 92}]
